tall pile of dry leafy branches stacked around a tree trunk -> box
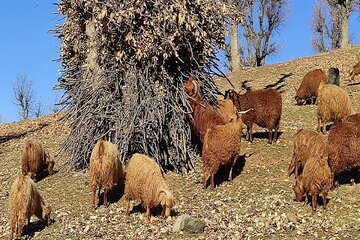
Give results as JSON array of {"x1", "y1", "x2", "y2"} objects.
[{"x1": 54, "y1": 0, "x2": 228, "y2": 171}]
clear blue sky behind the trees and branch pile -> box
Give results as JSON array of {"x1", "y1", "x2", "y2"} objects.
[{"x1": 0, "y1": 0, "x2": 360, "y2": 122}]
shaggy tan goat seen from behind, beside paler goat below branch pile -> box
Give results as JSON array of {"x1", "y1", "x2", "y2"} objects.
[{"x1": 90, "y1": 140, "x2": 125, "y2": 208}]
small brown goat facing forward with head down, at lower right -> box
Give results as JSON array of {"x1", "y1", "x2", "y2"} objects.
[{"x1": 293, "y1": 156, "x2": 333, "y2": 211}]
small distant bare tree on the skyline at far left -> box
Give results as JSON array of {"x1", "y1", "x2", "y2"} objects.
[{"x1": 13, "y1": 73, "x2": 34, "y2": 119}]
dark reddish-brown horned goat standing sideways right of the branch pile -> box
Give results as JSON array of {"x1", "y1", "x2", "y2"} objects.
[{"x1": 225, "y1": 89, "x2": 282, "y2": 143}]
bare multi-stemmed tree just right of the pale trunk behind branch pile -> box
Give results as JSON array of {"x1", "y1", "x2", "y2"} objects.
[{"x1": 240, "y1": 0, "x2": 288, "y2": 66}]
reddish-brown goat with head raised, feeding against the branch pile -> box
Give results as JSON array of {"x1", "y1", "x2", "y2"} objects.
[{"x1": 184, "y1": 77, "x2": 226, "y2": 143}]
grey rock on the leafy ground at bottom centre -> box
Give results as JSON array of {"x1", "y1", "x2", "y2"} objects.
[{"x1": 173, "y1": 214, "x2": 205, "y2": 233}]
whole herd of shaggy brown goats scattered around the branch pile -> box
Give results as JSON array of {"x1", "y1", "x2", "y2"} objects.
[{"x1": 4, "y1": 62, "x2": 360, "y2": 239}]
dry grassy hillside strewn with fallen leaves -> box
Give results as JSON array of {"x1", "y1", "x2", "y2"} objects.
[{"x1": 0, "y1": 46, "x2": 360, "y2": 239}]
